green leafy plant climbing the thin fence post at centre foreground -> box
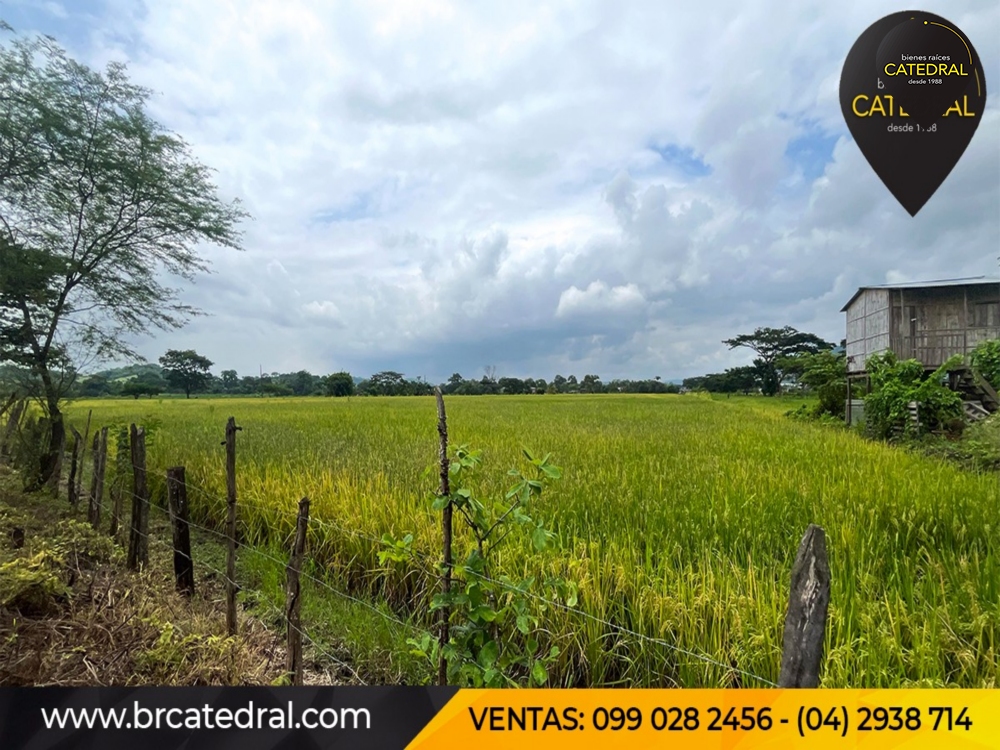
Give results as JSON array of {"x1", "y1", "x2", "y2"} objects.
[{"x1": 379, "y1": 445, "x2": 577, "y2": 687}]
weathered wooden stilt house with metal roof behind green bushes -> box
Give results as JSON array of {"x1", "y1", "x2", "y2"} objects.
[{"x1": 841, "y1": 276, "x2": 1000, "y2": 421}]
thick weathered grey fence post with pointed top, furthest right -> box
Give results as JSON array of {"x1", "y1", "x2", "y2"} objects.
[{"x1": 778, "y1": 524, "x2": 830, "y2": 688}]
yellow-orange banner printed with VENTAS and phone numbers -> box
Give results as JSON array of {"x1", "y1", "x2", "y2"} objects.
[{"x1": 408, "y1": 689, "x2": 1000, "y2": 750}]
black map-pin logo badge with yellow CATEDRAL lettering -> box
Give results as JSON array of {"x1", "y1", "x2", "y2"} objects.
[{"x1": 840, "y1": 11, "x2": 986, "y2": 216}]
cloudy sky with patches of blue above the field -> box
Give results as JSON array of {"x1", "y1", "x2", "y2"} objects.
[{"x1": 0, "y1": 0, "x2": 1000, "y2": 381}]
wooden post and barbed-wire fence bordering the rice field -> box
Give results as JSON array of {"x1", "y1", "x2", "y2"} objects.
[{"x1": 0, "y1": 394, "x2": 830, "y2": 687}]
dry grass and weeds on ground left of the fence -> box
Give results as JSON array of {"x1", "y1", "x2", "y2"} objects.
[{"x1": 0, "y1": 467, "x2": 356, "y2": 686}]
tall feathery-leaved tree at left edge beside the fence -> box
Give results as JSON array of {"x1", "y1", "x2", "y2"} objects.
[{"x1": 0, "y1": 27, "x2": 246, "y2": 485}]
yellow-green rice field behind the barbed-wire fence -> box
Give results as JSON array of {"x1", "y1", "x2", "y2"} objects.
[{"x1": 70, "y1": 395, "x2": 1000, "y2": 687}]
